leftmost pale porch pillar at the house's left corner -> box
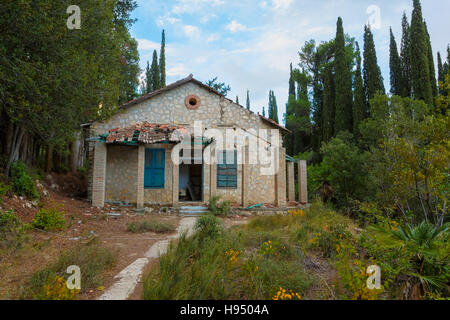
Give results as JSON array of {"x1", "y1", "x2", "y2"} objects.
[{"x1": 92, "y1": 141, "x2": 107, "y2": 208}]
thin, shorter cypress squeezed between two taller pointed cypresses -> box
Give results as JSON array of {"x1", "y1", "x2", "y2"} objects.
[{"x1": 353, "y1": 42, "x2": 368, "y2": 136}]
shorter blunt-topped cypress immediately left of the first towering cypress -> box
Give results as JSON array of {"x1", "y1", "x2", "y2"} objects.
[{"x1": 322, "y1": 65, "x2": 337, "y2": 142}]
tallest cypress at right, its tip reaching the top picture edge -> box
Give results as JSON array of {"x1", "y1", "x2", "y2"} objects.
[{"x1": 411, "y1": 0, "x2": 433, "y2": 105}]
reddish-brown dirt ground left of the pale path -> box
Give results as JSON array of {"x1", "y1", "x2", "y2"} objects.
[{"x1": 0, "y1": 178, "x2": 180, "y2": 299}]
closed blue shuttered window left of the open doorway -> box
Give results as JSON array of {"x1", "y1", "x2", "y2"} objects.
[{"x1": 144, "y1": 149, "x2": 166, "y2": 189}]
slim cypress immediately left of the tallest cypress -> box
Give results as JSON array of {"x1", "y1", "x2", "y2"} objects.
[{"x1": 400, "y1": 13, "x2": 412, "y2": 98}]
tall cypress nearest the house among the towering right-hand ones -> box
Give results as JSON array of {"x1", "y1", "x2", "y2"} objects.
[{"x1": 332, "y1": 17, "x2": 353, "y2": 134}]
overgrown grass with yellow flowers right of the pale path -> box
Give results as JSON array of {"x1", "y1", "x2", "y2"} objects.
[{"x1": 143, "y1": 215, "x2": 314, "y2": 300}]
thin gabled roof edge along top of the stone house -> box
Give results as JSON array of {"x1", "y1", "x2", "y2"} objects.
[{"x1": 119, "y1": 74, "x2": 292, "y2": 133}]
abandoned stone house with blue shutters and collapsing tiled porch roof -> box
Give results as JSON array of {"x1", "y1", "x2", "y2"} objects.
[{"x1": 88, "y1": 75, "x2": 307, "y2": 208}]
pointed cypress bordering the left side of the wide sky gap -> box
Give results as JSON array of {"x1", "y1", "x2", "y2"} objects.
[{"x1": 363, "y1": 26, "x2": 385, "y2": 110}]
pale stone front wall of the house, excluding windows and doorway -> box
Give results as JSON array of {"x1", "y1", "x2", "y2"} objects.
[{"x1": 88, "y1": 78, "x2": 298, "y2": 207}]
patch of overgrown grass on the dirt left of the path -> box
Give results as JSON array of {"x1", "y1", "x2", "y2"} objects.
[{"x1": 22, "y1": 239, "x2": 117, "y2": 300}]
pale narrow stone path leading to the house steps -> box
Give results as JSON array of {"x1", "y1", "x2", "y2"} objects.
[{"x1": 98, "y1": 217, "x2": 197, "y2": 300}]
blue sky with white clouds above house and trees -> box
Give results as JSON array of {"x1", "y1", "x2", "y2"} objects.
[{"x1": 131, "y1": 0, "x2": 450, "y2": 120}]
